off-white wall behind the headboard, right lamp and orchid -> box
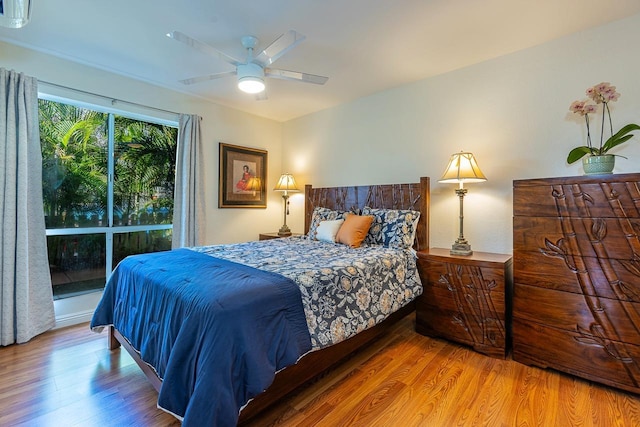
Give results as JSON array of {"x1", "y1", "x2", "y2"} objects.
[{"x1": 283, "y1": 15, "x2": 640, "y2": 253}]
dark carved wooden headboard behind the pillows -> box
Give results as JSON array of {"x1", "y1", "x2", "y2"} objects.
[{"x1": 304, "y1": 177, "x2": 430, "y2": 250}]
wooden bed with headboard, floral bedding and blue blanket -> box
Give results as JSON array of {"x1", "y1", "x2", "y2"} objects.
[{"x1": 91, "y1": 177, "x2": 429, "y2": 426}]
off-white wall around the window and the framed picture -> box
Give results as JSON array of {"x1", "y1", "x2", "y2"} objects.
[{"x1": 0, "y1": 42, "x2": 282, "y2": 327}]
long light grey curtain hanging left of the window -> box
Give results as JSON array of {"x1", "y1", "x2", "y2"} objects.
[{"x1": 0, "y1": 68, "x2": 55, "y2": 345}]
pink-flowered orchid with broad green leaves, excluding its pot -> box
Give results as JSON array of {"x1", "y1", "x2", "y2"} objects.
[{"x1": 567, "y1": 82, "x2": 640, "y2": 164}]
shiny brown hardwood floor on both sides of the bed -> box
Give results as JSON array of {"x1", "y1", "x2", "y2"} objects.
[{"x1": 0, "y1": 315, "x2": 640, "y2": 427}]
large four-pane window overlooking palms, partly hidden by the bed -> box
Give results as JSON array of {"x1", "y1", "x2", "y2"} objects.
[{"x1": 39, "y1": 99, "x2": 178, "y2": 299}]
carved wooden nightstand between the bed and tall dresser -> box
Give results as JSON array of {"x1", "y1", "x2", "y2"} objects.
[{"x1": 416, "y1": 248, "x2": 513, "y2": 358}]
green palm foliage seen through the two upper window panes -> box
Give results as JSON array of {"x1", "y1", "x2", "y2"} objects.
[{"x1": 39, "y1": 100, "x2": 177, "y2": 228}]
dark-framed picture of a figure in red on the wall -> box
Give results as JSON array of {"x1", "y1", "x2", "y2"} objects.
[{"x1": 218, "y1": 142, "x2": 267, "y2": 208}]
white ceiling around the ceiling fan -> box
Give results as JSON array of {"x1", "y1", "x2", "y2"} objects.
[{"x1": 0, "y1": 0, "x2": 640, "y2": 121}]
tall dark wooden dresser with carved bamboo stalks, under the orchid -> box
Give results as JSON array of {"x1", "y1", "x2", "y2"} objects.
[{"x1": 513, "y1": 173, "x2": 640, "y2": 393}]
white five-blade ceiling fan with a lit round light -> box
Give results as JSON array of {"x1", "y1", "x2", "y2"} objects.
[{"x1": 167, "y1": 30, "x2": 329, "y2": 94}]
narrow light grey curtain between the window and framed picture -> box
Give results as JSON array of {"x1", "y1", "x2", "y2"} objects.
[{"x1": 171, "y1": 114, "x2": 205, "y2": 249}]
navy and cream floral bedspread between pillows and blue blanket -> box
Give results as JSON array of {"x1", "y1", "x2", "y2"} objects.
[{"x1": 190, "y1": 236, "x2": 422, "y2": 349}]
